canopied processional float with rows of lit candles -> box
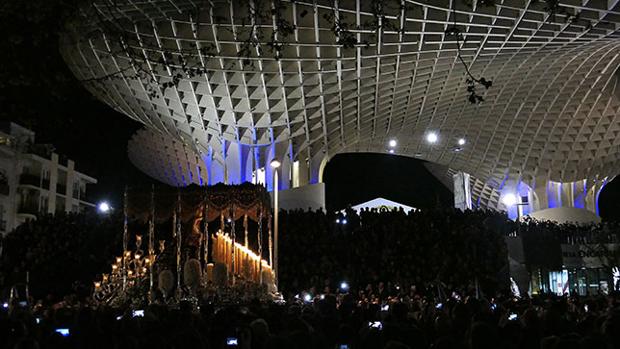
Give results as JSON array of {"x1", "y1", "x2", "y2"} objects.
[{"x1": 93, "y1": 183, "x2": 278, "y2": 306}]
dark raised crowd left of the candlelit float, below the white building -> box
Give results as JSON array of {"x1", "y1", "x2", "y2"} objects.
[{"x1": 0, "y1": 213, "x2": 122, "y2": 298}]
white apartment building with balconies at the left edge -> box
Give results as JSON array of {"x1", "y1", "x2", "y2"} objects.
[{"x1": 0, "y1": 123, "x2": 97, "y2": 234}]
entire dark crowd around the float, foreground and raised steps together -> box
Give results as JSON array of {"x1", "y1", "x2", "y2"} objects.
[{"x1": 0, "y1": 209, "x2": 620, "y2": 349}]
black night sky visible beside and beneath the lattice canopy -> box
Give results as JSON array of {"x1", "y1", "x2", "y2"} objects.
[{"x1": 0, "y1": 0, "x2": 620, "y2": 219}]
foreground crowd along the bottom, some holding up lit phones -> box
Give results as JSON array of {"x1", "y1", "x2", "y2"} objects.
[{"x1": 0, "y1": 285, "x2": 620, "y2": 349}]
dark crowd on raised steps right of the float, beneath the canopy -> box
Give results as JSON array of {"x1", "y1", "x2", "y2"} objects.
[{"x1": 279, "y1": 209, "x2": 510, "y2": 298}]
